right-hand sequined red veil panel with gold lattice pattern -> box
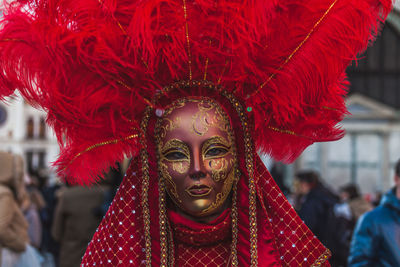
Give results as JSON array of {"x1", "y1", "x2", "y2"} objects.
[{"x1": 256, "y1": 157, "x2": 331, "y2": 266}]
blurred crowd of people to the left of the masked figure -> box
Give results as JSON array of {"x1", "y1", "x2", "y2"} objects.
[{"x1": 0, "y1": 152, "x2": 122, "y2": 267}]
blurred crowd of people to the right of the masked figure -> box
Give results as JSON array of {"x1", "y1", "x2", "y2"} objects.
[{"x1": 283, "y1": 161, "x2": 400, "y2": 267}]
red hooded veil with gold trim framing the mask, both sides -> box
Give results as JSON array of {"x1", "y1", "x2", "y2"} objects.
[{"x1": 82, "y1": 85, "x2": 330, "y2": 266}]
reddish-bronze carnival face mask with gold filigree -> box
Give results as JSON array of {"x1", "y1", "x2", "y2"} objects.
[{"x1": 158, "y1": 99, "x2": 236, "y2": 220}]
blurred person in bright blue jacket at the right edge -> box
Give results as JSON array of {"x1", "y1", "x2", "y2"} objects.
[{"x1": 349, "y1": 160, "x2": 400, "y2": 267}]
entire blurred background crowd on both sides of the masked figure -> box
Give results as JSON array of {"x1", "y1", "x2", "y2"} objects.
[{"x1": 0, "y1": 152, "x2": 400, "y2": 267}]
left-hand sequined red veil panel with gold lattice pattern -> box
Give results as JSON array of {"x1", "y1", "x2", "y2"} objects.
[{"x1": 81, "y1": 159, "x2": 145, "y2": 266}]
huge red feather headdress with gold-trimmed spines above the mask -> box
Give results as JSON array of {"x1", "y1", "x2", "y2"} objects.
[{"x1": 0, "y1": 0, "x2": 392, "y2": 183}]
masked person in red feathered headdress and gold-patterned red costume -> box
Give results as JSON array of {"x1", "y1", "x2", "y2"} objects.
[{"x1": 0, "y1": 0, "x2": 391, "y2": 266}]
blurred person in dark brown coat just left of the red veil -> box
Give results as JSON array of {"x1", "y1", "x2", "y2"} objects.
[{"x1": 51, "y1": 176, "x2": 109, "y2": 267}]
